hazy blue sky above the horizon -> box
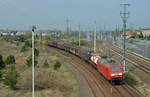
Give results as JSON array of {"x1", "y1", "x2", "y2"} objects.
[{"x1": 0, "y1": 0, "x2": 150, "y2": 30}]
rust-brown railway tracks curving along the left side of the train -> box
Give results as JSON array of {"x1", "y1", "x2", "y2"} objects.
[{"x1": 49, "y1": 45, "x2": 142, "y2": 97}]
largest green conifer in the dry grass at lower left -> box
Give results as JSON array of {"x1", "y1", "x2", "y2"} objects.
[{"x1": 4, "y1": 64, "x2": 19, "y2": 89}]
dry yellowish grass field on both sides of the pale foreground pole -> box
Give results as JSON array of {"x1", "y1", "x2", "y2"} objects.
[{"x1": 0, "y1": 39, "x2": 79, "y2": 97}]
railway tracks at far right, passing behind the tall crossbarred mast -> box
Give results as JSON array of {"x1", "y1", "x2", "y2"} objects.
[{"x1": 109, "y1": 46, "x2": 150, "y2": 74}]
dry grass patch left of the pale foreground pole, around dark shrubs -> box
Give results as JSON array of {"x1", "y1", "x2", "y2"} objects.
[{"x1": 0, "y1": 40, "x2": 32, "y2": 97}]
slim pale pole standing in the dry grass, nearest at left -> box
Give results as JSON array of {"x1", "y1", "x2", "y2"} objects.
[{"x1": 32, "y1": 26, "x2": 36, "y2": 97}]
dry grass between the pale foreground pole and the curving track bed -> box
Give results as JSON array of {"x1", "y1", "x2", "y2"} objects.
[{"x1": 35, "y1": 44, "x2": 79, "y2": 97}]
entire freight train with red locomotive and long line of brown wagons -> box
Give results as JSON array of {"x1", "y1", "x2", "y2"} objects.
[{"x1": 48, "y1": 42, "x2": 123, "y2": 84}]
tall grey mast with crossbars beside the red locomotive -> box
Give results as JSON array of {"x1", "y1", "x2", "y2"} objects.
[{"x1": 120, "y1": 4, "x2": 130, "y2": 72}]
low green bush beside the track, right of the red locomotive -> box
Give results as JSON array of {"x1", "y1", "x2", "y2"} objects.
[{"x1": 124, "y1": 73, "x2": 137, "y2": 85}]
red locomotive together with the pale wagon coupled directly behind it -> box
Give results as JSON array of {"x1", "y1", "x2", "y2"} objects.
[{"x1": 89, "y1": 53, "x2": 123, "y2": 84}]
